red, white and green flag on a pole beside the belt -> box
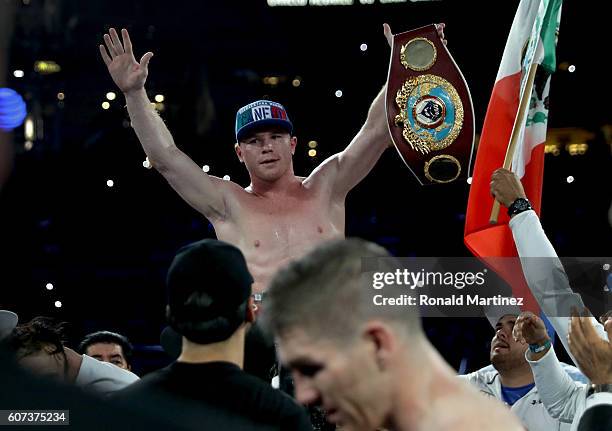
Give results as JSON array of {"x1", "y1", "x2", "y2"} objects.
[{"x1": 464, "y1": 0, "x2": 562, "y2": 311}]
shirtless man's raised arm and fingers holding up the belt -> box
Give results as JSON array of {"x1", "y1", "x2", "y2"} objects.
[{"x1": 313, "y1": 24, "x2": 446, "y2": 199}]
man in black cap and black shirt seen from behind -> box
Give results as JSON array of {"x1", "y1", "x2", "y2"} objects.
[{"x1": 119, "y1": 239, "x2": 312, "y2": 431}]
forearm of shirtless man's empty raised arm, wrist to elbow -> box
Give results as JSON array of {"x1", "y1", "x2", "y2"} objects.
[{"x1": 125, "y1": 89, "x2": 176, "y2": 170}]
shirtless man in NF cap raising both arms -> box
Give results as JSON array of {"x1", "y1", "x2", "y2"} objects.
[{"x1": 100, "y1": 24, "x2": 444, "y2": 294}]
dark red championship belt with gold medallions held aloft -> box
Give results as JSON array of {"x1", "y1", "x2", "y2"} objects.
[{"x1": 387, "y1": 24, "x2": 474, "y2": 184}]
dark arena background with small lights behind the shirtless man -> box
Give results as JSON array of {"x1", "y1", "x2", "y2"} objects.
[{"x1": 0, "y1": 0, "x2": 612, "y2": 376}]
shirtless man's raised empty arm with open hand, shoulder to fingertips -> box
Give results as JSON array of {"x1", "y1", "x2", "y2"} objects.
[{"x1": 100, "y1": 28, "x2": 226, "y2": 220}]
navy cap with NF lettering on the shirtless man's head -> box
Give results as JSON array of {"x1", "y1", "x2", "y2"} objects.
[{"x1": 236, "y1": 100, "x2": 293, "y2": 142}]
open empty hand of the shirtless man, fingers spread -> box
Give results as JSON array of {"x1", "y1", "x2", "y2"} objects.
[{"x1": 100, "y1": 28, "x2": 153, "y2": 93}]
